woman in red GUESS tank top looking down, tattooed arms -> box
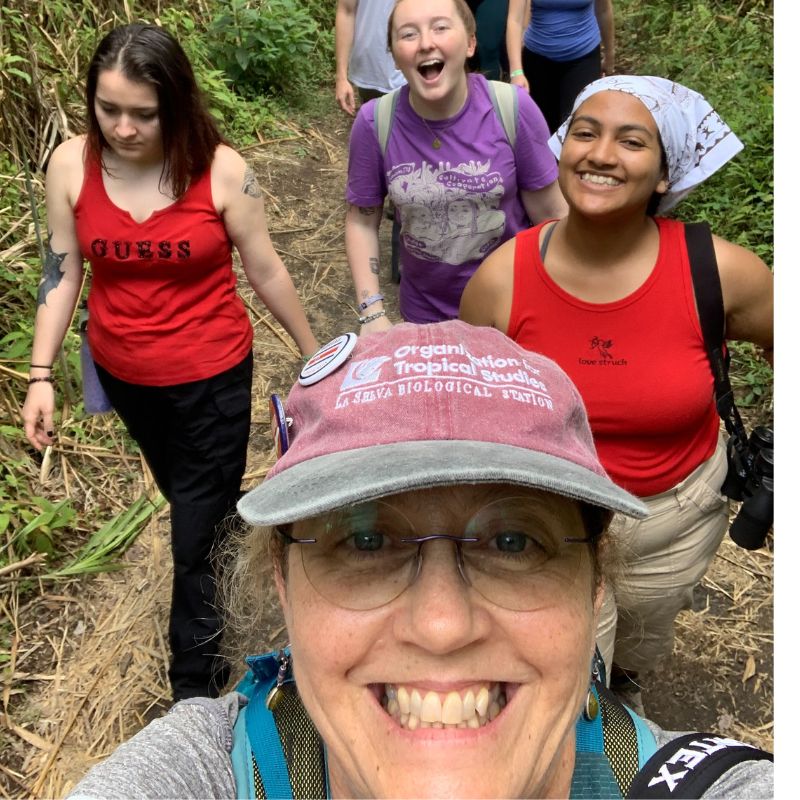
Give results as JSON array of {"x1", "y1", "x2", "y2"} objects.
[{"x1": 22, "y1": 24, "x2": 317, "y2": 700}]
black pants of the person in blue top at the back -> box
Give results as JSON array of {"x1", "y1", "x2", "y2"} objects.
[{"x1": 522, "y1": 45, "x2": 600, "y2": 133}]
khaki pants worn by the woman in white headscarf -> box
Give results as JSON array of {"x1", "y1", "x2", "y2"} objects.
[{"x1": 597, "y1": 433, "x2": 729, "y2": 675}]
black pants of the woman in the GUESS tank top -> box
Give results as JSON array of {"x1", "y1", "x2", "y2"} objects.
[{"x1": 97, "y1": 352, "x2": 253, "y2": 701}]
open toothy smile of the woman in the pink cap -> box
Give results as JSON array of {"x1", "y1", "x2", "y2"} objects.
[{"x1": 381, "y1": 683, "x2": 507, "y2": 731}]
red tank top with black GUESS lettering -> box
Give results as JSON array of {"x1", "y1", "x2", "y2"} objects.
[{"x1": 74, "y1": 159, "x2": 253, "y2": 386}]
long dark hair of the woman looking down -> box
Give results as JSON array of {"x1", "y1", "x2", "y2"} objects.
[{"x1": 86, "y1": 23, "x2": 225, "y2": 197}]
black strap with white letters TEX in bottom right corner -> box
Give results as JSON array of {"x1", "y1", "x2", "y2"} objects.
[{"x1": 626, "y1": 733, "x2": 773, "y2": 800}]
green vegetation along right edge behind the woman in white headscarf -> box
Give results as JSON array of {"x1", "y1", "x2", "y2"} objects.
[{"x1": 614, "y1": 0, "x2": 774, "y2": 414}]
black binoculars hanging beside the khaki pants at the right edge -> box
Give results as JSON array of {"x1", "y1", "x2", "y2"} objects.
[{"x1": 721, "y1": 425, "x2": 775, "y2": 550}]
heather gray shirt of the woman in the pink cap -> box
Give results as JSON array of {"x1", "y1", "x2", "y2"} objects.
[{"x1": 67, "y1": 692, "x2": 774, "y2": 800}]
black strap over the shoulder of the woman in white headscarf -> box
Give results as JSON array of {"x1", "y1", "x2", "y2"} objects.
[{"x1": 684, "y1": 222, "x2": 747, "y2": 455}]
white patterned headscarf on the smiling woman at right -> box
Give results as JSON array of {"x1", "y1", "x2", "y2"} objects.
[{"x1": 547, "y1": 75, "x2": 744, "y2": 213}]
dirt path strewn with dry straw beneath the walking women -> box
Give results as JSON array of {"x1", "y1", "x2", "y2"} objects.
[{"x1": 0, "y1": 97, "x2": 773, "y2": 797}]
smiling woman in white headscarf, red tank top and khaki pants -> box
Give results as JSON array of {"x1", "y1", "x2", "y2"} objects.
[{"x1": 460, "y1": 76, "x2": 773, "y2": 712}]
